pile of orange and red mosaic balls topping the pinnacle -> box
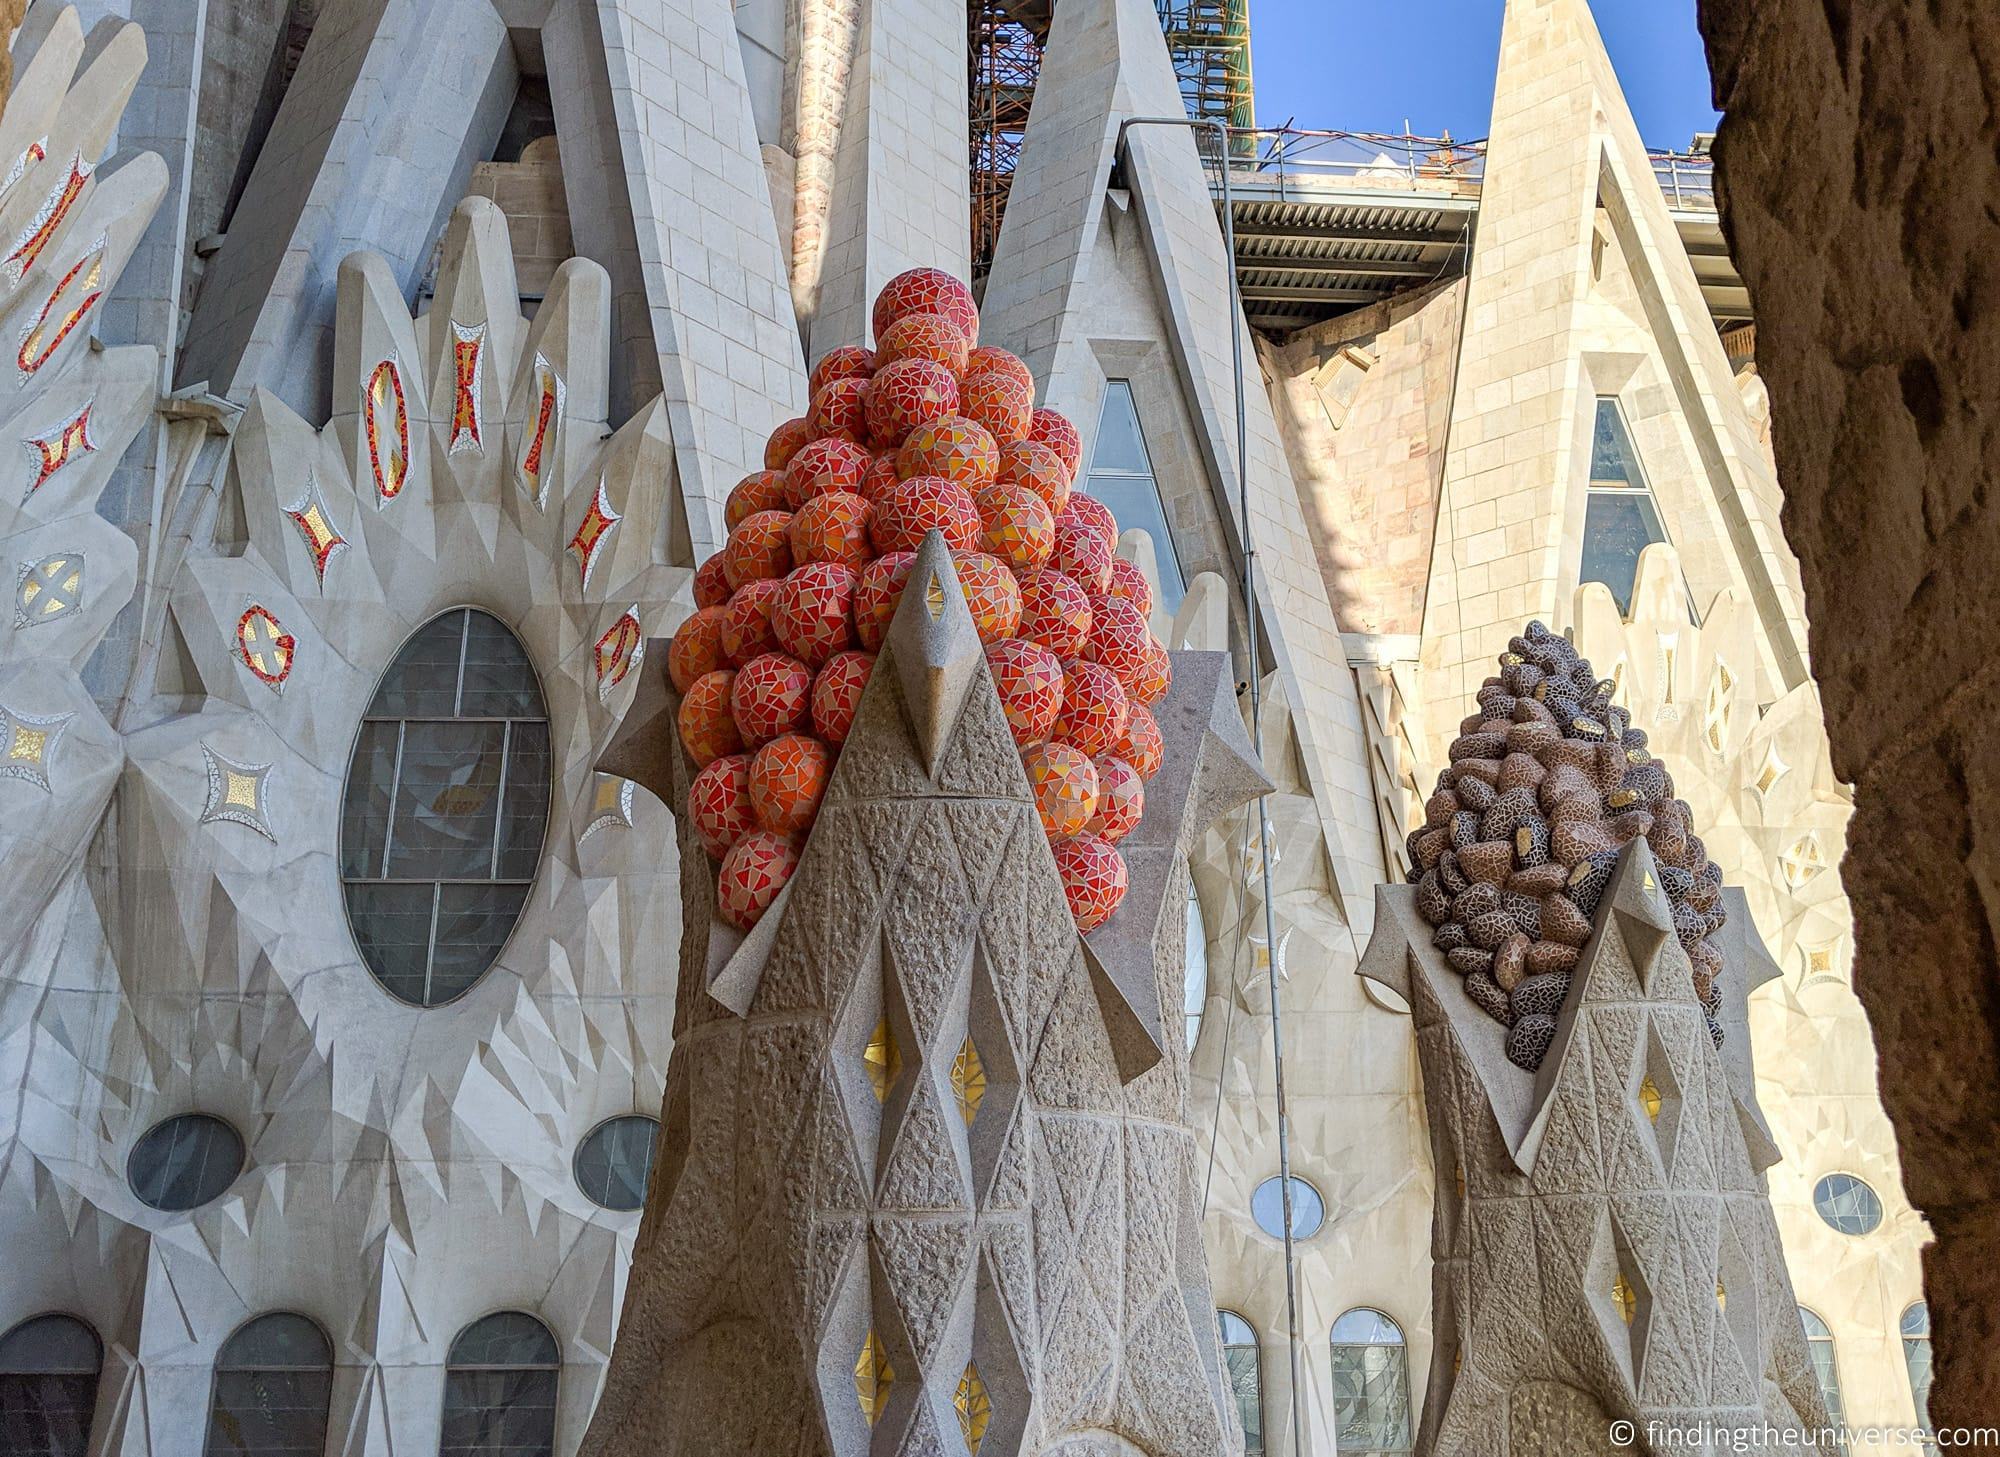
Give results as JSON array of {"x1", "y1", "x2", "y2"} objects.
[{"x1": 668, "y1": 268, "x2": 1172, "y2": 931}]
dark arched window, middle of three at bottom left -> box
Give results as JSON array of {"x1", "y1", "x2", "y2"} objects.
[{"x1": 204, "y1": 1311, "x2": 334, "y2": 1457}]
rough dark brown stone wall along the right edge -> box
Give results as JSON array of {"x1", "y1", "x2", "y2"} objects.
[{"x1": 1700, "y1": 0, "x2": 2000, "y2": 1425}]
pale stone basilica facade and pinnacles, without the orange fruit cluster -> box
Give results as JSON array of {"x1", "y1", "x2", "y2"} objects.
[{"x1": 0, "y1": 0, "x2": 1930, "y2": 1457}]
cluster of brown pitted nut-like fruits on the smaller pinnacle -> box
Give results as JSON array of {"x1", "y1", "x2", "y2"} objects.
[{"x1": 1410, "y1": 622, "x2": 1724, "y2": 1073}]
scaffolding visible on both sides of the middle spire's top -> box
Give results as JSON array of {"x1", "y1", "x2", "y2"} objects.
[{"x1": 966, "y1": 0, "x2": 1254, "y2": 278}]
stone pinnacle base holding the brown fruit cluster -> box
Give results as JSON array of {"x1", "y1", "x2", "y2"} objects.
[{"x1": 1360, "y1": 839, "x2": 1826, "y2": 1457}]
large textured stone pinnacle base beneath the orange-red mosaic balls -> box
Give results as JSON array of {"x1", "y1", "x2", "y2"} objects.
[{"x1": 584, "y1": 532, "x2": 1264, "y2": 1457}]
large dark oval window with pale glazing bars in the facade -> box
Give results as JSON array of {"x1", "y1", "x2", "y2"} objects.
[{"x1": 340, "y1": 606, "x2": 550, "y2": 1007}]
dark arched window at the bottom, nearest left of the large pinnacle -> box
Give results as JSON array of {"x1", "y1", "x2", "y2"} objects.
[{"x1": 438, "y1": 1311, "x2": 562, "y2": 1457}]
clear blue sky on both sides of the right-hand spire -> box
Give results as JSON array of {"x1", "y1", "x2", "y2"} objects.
[{"x1": 1250, "y1": 0, "x2": 1716, "y2": 148}]
